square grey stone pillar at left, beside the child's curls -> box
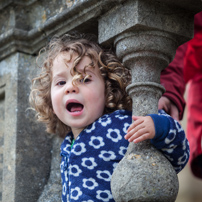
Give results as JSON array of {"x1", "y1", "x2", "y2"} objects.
[{"x1": 0, "y1": 53, "x2": 52, "y2": 202}]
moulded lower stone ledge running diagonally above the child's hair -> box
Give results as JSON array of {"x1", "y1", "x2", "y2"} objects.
[{"x1": 0, "y1": 0, "x2": 124, "y2": 60}]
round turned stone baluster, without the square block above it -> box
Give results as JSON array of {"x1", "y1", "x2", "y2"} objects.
[{"x1": 111, "y1": 30, "x2": 179, "y2": 202}]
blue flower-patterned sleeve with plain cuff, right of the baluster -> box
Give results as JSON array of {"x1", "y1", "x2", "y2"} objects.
[{"x1": 149, "y1": 110, "x2": 190, "y2": 173}]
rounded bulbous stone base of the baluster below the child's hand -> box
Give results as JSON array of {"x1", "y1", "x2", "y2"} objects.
[{"x1": 111, "y1": 141, "x2": 179, "y2": 202}]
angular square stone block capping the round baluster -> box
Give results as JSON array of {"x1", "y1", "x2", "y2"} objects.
[{"x1": 99, "y1": 0, "x2": 196, "y2": 43}]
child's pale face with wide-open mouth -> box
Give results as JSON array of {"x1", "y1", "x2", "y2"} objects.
[{"x1": 51, "y1": 52, "x2": 105, "y2": 138}]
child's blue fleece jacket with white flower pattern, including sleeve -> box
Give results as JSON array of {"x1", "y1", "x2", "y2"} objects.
[{"x1": 61, "y1": 110, "x2": 189, "y2": 202}]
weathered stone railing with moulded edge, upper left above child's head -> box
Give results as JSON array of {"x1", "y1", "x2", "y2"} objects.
[{"x1": 0, "y1": 0, "x2": 124, "y2": 59}]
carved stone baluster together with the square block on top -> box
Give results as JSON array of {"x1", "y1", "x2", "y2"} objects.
[{"x1": 99, "y1": 0, "x2": 200, "y2": 202}]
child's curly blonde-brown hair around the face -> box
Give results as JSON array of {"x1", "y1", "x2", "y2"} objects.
[{"x1": 29, "y1": 34, "x2": 132, "y2": 137}]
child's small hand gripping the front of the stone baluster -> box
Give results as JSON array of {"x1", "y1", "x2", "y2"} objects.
[{"x1": 125, "y1": 116, "x2": 155, "y2": 143}]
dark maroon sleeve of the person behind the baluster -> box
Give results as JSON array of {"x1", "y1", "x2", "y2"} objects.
[{"x1": 160, "y1": 43, "x2": 187, "y2": 120}]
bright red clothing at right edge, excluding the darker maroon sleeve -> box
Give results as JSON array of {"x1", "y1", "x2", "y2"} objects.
[{"x1": 184, "y1": 15, "x2": 202, "y2": 178}]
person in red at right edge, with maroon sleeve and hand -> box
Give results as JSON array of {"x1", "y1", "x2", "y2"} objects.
[{"x1": 158, "y1": 12, "x2": 202, "y2": 178}]
